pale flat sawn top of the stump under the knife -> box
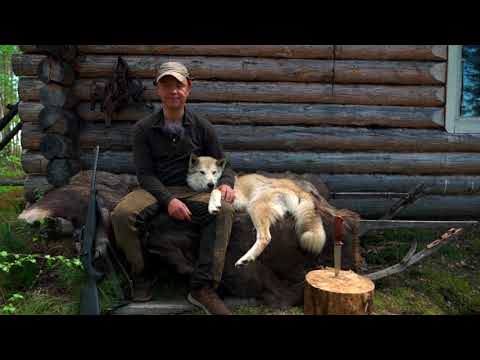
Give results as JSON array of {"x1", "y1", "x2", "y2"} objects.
[{"x1": 306, "y1": 268, "x2": 375, "y2": 294}]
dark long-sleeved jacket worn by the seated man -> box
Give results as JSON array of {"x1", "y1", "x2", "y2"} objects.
[{"x1": 133, "y1": 108, "x2": 235, "y2": 209}]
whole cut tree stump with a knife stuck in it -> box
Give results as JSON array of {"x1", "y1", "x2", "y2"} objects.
[{"x1": 304, "y1": 268, "x2": 375, "y2": 315}]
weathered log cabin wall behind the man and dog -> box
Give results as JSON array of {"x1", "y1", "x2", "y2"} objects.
[{"x1": 14, "y1": 45, "x2": 480, "y2": 219}]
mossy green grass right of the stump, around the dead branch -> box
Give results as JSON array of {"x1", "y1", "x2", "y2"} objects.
[{"x1": 363, "y1": 230, "x2": 480, "y2": 315}]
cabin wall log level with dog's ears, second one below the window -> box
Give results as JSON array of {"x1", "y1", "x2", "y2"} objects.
[{"x1": 22, "y1": 149, "x2": 480, "y2": 175}]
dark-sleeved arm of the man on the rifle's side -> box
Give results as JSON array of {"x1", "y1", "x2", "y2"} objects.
[{"x1": 133, "y1": 126, "x2": 174, "y2": 209}]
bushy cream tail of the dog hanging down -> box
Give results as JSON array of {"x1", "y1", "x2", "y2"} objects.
[{"x1": 293, "y1": 193, "x2": 326, "y2": 255}]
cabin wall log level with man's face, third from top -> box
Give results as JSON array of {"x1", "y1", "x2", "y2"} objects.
[{"x1": 19, "y1": 78, "x2": 445, "y2": 107}]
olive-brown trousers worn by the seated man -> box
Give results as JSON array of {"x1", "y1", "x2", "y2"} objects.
[{"x1": 112, "y1": 187, "x2": 234, "y2": 289}]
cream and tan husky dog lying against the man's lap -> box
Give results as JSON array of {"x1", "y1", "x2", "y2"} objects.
[{"x1": 187, "y1": 154, "x2": 325, "y2": 266}]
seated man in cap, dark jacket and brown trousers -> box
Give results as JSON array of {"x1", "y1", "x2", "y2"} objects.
[{"x1": 112, "y1": 62, "x2": 235, "y2": 315}]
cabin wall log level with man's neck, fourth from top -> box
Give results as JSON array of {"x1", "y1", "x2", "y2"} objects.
[{"x1": 19, "y1": 102, "x2": 444, "y2": 128}]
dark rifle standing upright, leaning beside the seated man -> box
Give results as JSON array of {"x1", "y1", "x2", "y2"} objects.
[{"x1": 80, "y1": 145, "x2": 103, "y2": 315}]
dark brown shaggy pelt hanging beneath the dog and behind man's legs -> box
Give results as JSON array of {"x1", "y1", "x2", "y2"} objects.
[{"x1": 147, "y1": 198, "x2": 360, "y2": 308}]
